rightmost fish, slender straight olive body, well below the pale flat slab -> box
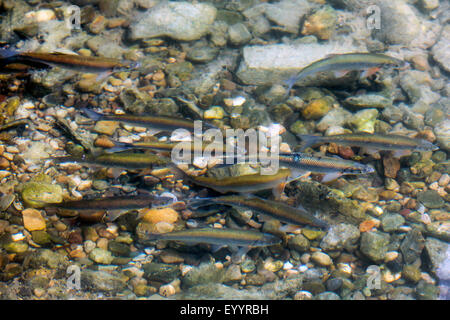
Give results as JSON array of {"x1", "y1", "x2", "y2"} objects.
[{"x1": 299, "y1": 132, "x2": 439, "y2": 155}]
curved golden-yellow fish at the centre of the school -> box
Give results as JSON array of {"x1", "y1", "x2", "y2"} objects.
[{"x1": 172, "y1": 165, "x2": 291, "y2": 198}]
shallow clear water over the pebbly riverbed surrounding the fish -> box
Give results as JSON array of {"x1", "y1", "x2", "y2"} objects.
[{"x1": 0, "y1": 0, "x2": 450, "y2": 300}]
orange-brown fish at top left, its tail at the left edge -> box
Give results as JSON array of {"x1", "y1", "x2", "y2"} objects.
[{"x1": 0, "y1": 48, "x2": 139, "y2": 73}]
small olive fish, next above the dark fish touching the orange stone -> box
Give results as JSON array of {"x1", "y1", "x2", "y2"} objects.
[{"x1": 49, "y1": 152, "x2": 170, "y2": 169}]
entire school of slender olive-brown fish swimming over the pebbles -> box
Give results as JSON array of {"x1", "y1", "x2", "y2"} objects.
[{"x1": 0, "y1": 49, "x2": 438, "y2": 252}]
